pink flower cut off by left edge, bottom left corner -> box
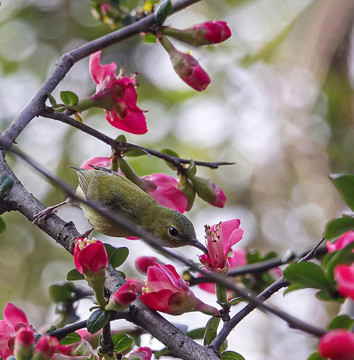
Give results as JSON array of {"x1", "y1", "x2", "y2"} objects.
[{"x1": 0, "y1": 303, "x2": 31, "y2": 359}]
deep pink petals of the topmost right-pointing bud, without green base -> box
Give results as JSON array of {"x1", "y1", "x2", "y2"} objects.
[{"x1": 192, "y1": 20, "x2": 231, "y2": 45}]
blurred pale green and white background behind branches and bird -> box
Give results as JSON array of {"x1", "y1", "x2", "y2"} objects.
[{"x1": 0, "y1": 0, "x2": 354, "y2": 360}]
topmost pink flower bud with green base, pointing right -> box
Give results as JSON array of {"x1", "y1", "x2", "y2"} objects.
[{"x1": 161, "y1": 20, "x2": 231, "y2": 46}]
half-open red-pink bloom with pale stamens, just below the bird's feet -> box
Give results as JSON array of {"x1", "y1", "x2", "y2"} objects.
[{"x1": 74, "y1": 238, "x2": 108, "y2": 275}]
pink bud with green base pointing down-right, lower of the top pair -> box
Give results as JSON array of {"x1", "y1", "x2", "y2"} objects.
[{"x1": 160, "y1": 36, "x2": 211, "y2": 91}]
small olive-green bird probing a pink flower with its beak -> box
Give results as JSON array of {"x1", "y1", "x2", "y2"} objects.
[{"x1": 65, "y1": 167, "x2": 208, "y2": 254}]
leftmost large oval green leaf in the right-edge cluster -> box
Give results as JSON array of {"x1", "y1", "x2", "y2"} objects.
[{"x1": 283, "y1": 262, "x2": 328, "y2": 289}]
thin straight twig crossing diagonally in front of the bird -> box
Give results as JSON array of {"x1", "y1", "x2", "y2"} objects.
[{"x1": 5, "y1": 148, "x2": 325, "y2": 337}]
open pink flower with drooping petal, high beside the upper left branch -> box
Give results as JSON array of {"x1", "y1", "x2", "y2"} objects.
[{"x1": 90, "y1": 51, "x2": 147, "y2": 134}]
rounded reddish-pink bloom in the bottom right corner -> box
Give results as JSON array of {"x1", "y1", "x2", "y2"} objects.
[{"x1": 318, "y1": 329, "x2": 354, "y2": 360}]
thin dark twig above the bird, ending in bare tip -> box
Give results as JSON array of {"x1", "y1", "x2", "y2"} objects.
[{"x1": 40, "y1": 107, "x2": 234, "y2": 171}]
